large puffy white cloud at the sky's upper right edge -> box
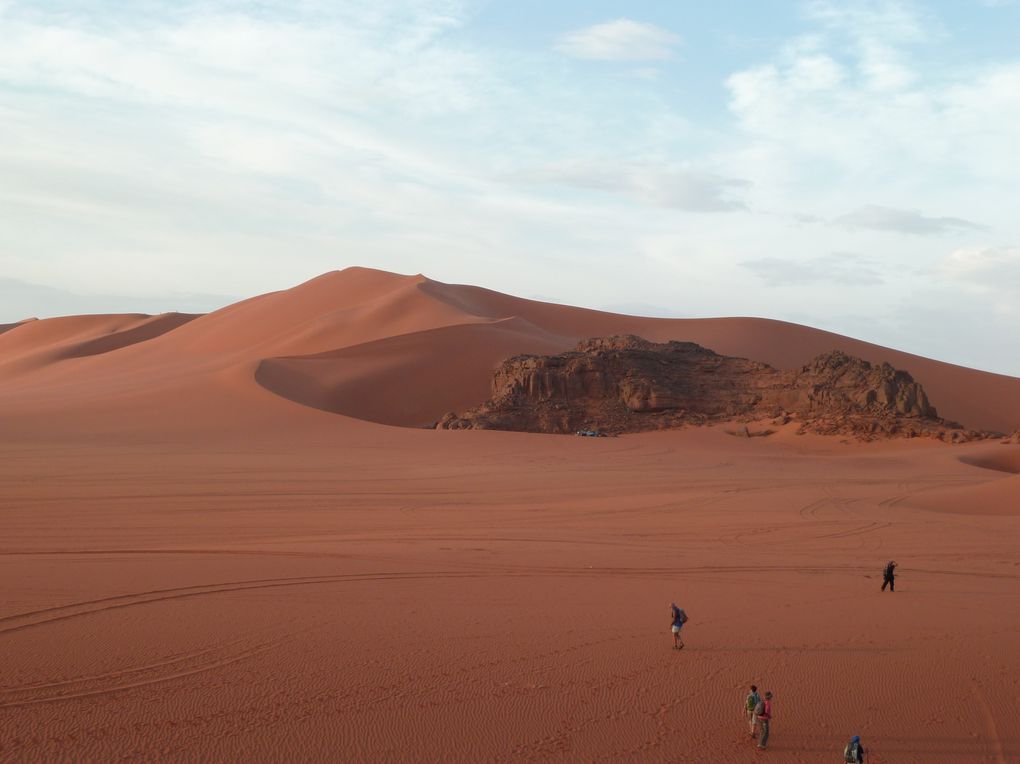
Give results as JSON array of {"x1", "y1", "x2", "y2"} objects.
[{"x1": 722, "y1": 2, "x2": 1020, "y2": 217}]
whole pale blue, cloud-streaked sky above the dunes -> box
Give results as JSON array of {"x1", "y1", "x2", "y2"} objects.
[{"x1": 0, "y1": 0, "x2": 1020, "y2": 375}]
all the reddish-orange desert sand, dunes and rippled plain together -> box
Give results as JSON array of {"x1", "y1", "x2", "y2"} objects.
[{"x1": 0, "y1": 269, "x2": 1020, "y2": 764}]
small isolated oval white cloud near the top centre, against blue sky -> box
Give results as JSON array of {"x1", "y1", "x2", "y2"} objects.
[{"x1": 556, "y1": 18, "x2": 680, "y2": 61}]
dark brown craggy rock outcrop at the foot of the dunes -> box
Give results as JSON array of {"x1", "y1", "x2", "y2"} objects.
[{"x1": 438, "y1": 336, "x2": 976, "y2": 441}]
